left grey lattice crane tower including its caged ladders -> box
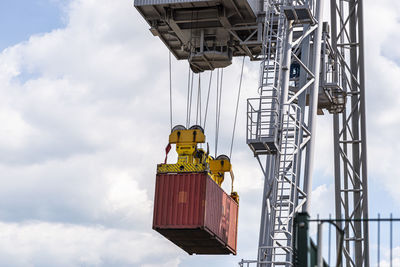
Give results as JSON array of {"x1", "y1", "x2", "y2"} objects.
[{"x1": 241, "y1": 1, "x2": 323, "y2": 267}]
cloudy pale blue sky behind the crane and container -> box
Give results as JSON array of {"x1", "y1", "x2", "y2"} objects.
[{"x1": 0, "y1": 0, "x2": 400, "y2": 267}]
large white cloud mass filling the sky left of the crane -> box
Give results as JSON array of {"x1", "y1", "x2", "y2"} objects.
[{"x1": 0, "y1": 1, "x2": 181, "y2": 266}]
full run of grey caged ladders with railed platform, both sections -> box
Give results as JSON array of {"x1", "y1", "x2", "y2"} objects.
[{"x1": 242, "y1": 1, "x2": 310, "y2": 267}]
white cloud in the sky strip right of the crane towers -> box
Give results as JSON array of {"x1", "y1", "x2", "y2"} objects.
[{"x1": 365, "y1": 0, "x2": 400, "y2": 207}]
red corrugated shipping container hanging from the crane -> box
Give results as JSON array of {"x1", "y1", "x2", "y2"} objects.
[{"x1": 153, "y1": 173, "x2": 238, "y2": 255}]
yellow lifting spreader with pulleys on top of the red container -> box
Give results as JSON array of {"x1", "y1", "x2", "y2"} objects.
[{"x1": 157, "y1": 125, "x2": 239, "y2": 203}]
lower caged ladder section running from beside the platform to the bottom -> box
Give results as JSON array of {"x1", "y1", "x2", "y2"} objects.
[{"x1": 263, "y1": 104, "x2": 300, "y2": 266}]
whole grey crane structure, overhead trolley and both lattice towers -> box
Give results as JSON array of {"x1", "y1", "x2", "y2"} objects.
[{"x1": 135, "y1": 0, "x2": 369, "y2": 267}]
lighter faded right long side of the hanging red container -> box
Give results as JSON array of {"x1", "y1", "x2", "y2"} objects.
[{"x1": 204, "y1": 179, "x2": 238, "y2": 255}]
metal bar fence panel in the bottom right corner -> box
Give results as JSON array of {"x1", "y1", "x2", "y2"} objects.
[{"x1": 298, "y1": 214, "x2": 400, "y2": 267}]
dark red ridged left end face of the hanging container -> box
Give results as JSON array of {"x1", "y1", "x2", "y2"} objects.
[{"x1": 153, "y1": 173, "x2": 205, "y2": 229}]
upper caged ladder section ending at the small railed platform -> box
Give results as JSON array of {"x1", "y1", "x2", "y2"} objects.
[{"x1": 247, "y1": 1, "x2": 286, "y2": 155}]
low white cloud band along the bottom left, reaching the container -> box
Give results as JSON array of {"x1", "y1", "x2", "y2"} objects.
[{"x1": 0, "y1": 222, "x2": 179, "y2": 266}]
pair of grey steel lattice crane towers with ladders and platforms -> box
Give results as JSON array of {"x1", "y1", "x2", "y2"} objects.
[{"x1": 240, "y1": 0, "x2": 369, "y2": 267}]
